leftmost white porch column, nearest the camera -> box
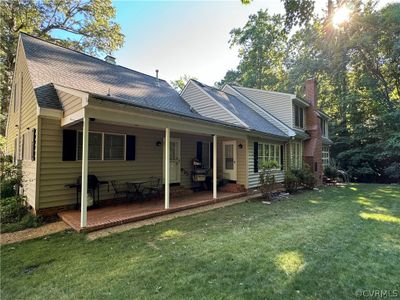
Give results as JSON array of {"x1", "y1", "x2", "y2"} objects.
[{"x1": 81, "y1": 114, "x2": 89, "y2": 228}]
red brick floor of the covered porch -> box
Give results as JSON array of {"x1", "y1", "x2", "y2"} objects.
[{"x1": 58, "y1": 192, "x2": 247, "y2": 232}]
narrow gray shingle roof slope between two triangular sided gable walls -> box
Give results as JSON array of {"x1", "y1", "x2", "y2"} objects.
[{"x1": 196, "y1": 81, "x2": 288, "y2": 137}]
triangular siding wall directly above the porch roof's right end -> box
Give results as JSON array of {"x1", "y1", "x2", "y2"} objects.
[{"x1": 181, "y1": 81, "x2": 242, "y2": 125}]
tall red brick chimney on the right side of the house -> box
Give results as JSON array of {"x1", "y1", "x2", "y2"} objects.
[{"x1": 303, "y1": 78, "x2": 323, "y2": 186}]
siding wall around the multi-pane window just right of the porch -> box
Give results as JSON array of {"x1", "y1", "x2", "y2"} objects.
[{"x1": 247, "y1": 138, "x2": 287, "y2": 188}]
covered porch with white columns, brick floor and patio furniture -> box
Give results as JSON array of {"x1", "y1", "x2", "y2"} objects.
[{"x1": 50, "y1": 91, "x2": 247, "y2": 231}]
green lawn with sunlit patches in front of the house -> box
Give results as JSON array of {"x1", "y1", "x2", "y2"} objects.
[{"x1": 0, "y1": 184, "x2": 400, "y2": 299}]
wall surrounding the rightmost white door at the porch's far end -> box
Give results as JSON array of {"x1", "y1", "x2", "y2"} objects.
[{"x1": 217, "y1": 137, "x2": 248, "y2": 188}]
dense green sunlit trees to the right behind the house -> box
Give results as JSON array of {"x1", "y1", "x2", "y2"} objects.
[{"x1": 227, "y1": 1, "x2": 400, "y2": 182}]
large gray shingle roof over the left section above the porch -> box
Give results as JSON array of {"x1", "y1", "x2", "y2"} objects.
[{"x1": 21, "y1": 34, "x2": 221, "y2": 123}]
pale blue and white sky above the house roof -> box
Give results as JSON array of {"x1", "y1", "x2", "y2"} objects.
[{"x1": 113, "y1": 0, "x2": 390, "y2": 85}]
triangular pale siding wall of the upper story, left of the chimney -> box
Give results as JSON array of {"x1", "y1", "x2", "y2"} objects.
[{"x1": 231, "y1": 87, "x2": 293, "y2": 127}]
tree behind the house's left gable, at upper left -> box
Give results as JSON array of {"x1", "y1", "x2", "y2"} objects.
[{"x1": 0, "y1": 0, "x2": 124, "y2": 132}]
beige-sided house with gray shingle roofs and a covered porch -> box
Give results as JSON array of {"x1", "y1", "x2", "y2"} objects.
[{"x1": 6, "y1": 34, "x2": 327, "y2": 228}]
